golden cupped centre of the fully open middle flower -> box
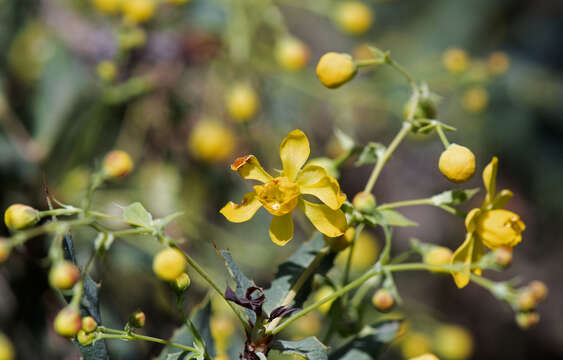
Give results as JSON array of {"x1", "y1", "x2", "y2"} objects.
[{"x1": 254, "y1": 176, "x2": 299, "y2": 216}]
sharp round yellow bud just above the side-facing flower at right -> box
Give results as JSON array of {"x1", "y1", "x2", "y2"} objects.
[{"x1": 438, "y1": 144, "x2": 475, "y2": 183}]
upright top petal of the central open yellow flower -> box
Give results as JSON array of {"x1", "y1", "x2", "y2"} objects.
[{"x1": 280, "y1": 130, "x2": 311, "y2": 180}]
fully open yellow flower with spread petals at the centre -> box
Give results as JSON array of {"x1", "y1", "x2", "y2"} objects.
[{"x1": 221, "y1": 130, "x2": 347, "y2": 246}]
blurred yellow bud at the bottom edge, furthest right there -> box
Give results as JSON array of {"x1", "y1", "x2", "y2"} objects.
[{"x1": 434, "y1": 325, "x2": 473, "y2": 360}]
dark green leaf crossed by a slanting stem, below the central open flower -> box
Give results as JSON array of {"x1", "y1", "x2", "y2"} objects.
[{"x1": 264, "y1": 233, "x2": 336, "y2": 313}]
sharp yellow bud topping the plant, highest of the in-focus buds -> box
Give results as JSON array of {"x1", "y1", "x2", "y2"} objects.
[{"x1": 316, "y1": 52, "x2": 358, "y2": 89}]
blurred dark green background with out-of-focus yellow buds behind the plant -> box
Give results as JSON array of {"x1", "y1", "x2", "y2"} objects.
[{"x1": 0, "y1": 0, "x2": 563, "y2": 360}]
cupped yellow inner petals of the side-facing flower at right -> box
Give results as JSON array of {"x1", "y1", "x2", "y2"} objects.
[{"x1": 476, "y1": 209, "x2": 526, "y2": 249}]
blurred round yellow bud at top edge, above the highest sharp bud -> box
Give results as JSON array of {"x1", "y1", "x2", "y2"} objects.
[{"x1": 335, "y1": 1, "x2": 373, "y2": 35}]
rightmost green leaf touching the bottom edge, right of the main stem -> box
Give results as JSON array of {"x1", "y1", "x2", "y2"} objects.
[{"x1": 328, "y1": 320, "x2": 401, "y2": 360}]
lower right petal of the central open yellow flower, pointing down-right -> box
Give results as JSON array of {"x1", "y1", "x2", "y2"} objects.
[{"x1": 299, "y1": 199, "x2": 348, "y2": 237}]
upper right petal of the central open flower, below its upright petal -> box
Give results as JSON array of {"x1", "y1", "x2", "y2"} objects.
[{"x1": 297, "y1": 165, "x2": 346, "y2": 210}]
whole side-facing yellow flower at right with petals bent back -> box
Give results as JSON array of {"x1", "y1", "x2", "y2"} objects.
[{"x1": 451, "y1": 157, "x2": 526, "y2": 288}]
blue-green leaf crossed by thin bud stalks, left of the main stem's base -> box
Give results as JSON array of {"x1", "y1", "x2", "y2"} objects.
[{"x1": 157, "y1": 300, "x2": 215, "y2": 360}]
